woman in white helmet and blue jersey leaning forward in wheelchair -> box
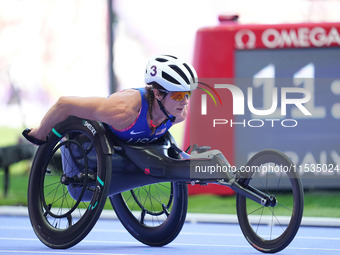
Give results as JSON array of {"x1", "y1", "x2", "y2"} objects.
[{"x1": 23, "y1": 55, "x2": 197, "y2": 145}]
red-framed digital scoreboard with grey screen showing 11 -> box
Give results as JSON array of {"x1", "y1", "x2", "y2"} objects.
[{"x1": 186, "y1": 22, "x2": 340, "y2": 188}]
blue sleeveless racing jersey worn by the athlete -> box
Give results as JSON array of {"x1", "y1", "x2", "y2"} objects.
[{"x1": 110, "y1": 88, "x2": 172, "y2": 143}]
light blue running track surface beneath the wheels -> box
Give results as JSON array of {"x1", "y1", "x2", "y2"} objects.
[{"x1": 0, "y1": 216, "x2": 340, "y2": 255}]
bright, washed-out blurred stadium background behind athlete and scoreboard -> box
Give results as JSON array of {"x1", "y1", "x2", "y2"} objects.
[{"x1": 0, "y1": 0, "x2": 340, "y2": 215}]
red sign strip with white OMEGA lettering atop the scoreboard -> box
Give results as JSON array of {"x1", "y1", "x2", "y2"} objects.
[{"x1": 235, "y1": 27, "x2": 340, "y2": 49}]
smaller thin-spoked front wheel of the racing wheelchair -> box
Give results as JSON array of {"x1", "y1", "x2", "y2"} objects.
[{"x1": 236, "y1": 150, "x2": 303, "y2": 253}]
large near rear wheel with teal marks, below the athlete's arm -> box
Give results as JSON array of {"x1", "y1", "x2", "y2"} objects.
[{"x1": 28, "y1": 118, "x2": 112, "y2": 249}]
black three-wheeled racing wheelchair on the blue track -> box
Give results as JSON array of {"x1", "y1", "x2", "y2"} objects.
[{"x1": 28, "y1": 116, "x2": 303, "y2": 253}]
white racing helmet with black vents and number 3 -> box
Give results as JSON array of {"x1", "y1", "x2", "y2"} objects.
[{"x1": 145, "y1": 55, "x2": 197, "y2": 91}]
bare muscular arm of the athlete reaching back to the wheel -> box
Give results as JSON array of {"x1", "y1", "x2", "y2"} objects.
[{"x1": 30, "y1": 90, "x2": 141, "y2": 140}]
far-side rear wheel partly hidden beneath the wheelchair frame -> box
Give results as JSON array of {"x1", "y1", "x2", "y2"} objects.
[{"x1": 110, "y1": 182, "x2": 188, "y2": 246}]
